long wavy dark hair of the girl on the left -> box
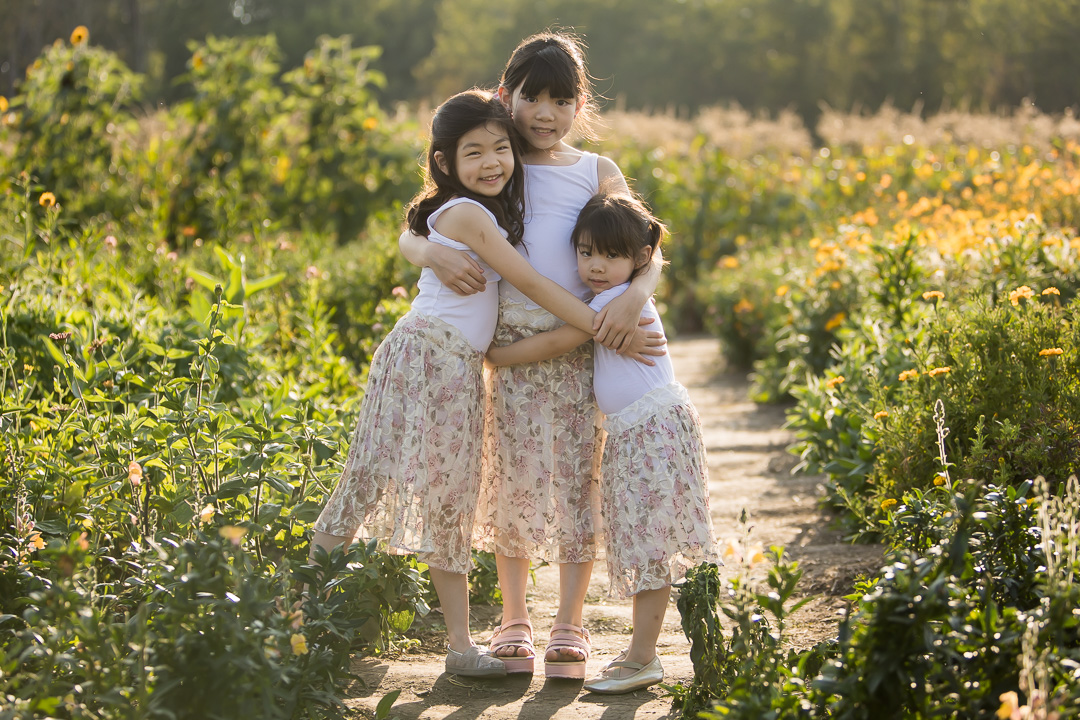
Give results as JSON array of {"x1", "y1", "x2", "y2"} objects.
[{"x1": 405, "y1": 90, "x2": 525, "y2": 245}]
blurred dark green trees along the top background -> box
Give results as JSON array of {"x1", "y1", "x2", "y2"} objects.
[{"x1": 0, "y1": 0, "x2": 1080, "y2": 128}]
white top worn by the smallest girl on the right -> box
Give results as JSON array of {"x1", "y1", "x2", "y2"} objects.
[{"x1": 589, "y1": 283, "x2": 675, "y2": 415}]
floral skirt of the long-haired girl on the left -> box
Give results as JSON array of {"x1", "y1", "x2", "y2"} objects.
[{"x1": 315, "y1": 312, "x2": 484, "y2": 573}]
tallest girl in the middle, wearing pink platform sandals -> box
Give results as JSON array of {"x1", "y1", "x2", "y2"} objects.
[{"x1": 401, "y1": 32, "x2": 661, "y2": 678}]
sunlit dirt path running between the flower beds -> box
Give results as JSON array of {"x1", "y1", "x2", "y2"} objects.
[{"x1": 348, "y1": 338, "x2": 880, "y2": 720}]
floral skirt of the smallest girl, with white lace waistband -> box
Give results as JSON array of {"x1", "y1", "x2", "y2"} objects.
[{"x1": 600, "y1": 382, "x2": 719, "y2": 597}]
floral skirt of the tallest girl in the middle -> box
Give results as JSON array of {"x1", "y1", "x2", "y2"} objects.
[{"x1": 475, "y1": 298, "x2": 603, "y2": 563}]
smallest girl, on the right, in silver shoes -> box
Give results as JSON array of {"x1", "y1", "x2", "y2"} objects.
[{"x1": 487, "y1": 192, "x2": 718, "y2": 694}]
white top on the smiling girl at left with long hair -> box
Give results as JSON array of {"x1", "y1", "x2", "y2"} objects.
[{"x1": 413, "y1": 198, "x2": 507, "y2": 352}]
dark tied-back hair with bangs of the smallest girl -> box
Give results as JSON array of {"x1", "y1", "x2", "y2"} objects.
[{"x1": 570, "y1": 190, "x2": 667, "y2": 279}]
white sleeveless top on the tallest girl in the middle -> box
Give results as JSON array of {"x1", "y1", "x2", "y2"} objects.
[{"x1": 502, "y1": 152, "x2": 599, "y2": 308}]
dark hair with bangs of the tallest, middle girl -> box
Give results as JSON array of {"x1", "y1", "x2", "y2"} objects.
[{"x1": 499, "y1": 31, "x2": 596, "y2": 143}]
